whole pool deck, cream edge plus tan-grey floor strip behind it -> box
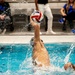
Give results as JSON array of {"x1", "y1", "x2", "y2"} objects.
[{"x1": 0, "y1": 28, "x2": 75, "y2": 44}]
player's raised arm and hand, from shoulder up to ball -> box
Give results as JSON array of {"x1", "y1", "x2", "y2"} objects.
[{"x1": 30, "y1": 17, "x2": 40, "y2": 41}]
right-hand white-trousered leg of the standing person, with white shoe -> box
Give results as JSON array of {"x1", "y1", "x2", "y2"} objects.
[{"x1": 44, "y1": 4, "x2": 55, "y2": 34}]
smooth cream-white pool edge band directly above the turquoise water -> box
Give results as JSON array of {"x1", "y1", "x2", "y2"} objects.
[{"x1": 0, "y1": 35, "x2": 75, "y2": 44}]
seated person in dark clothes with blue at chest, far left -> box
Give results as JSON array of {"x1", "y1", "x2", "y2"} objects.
[{"x1": 0, "y1": 0, "x2": 14, "y2": 34}]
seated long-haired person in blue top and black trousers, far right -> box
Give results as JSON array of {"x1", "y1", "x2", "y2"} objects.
[{"x1": 60, "y1": 0, "x2": 75, "y2": 31}]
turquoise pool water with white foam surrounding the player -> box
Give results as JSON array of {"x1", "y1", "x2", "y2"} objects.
[{"x1": 0, "y1": 43, "x2": 75, "y2": 75}]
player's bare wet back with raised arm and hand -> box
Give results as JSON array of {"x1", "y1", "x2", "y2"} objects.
[{"x1": 30, "y1": 17, "x2": 50, "y2": 67}]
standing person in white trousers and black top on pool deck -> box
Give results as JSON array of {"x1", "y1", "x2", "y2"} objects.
[{"x1": 35, "y1": 0, "x2": 55, "y2": 34}]
